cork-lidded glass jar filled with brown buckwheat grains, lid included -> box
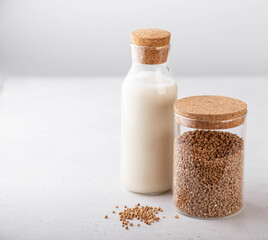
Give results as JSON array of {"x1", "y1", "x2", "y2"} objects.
[{"x1": 173, "y1": 96, "x2": 247, "y2": 218}]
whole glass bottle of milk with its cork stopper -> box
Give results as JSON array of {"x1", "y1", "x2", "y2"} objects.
[{"x1": 121, "y1": 29, "x2": 177, "y2": 194}]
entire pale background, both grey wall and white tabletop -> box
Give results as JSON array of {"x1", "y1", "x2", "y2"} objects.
[{"x1": 0, "y1": 0, "x2": 268, "y2": 240}]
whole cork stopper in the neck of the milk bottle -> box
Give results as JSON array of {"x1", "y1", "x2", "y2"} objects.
[{"x1": 131, "y1": 28, "x2": 171, "y2": 65}]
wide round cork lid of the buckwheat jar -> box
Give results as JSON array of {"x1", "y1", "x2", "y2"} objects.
[{"x1": 174, "y1": 95, "x2": 247, "y2": 129}]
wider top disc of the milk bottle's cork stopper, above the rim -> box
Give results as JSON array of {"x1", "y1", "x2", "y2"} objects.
[{"x1": 131, "y1": 28, "x2": 171, "y2": 47}]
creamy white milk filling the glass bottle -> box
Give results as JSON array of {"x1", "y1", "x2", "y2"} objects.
[{"x1": 121, "y1": 72, "x2": 177, "y2": 194}]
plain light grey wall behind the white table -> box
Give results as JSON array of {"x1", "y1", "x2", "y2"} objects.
[{"x1": 0, "y1": 0, "x2": 268, "y2": 75}]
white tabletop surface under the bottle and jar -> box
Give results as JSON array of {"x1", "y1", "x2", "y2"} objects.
[{"x1": 0, "y1": 76, "x2": 268, "y2": 240}]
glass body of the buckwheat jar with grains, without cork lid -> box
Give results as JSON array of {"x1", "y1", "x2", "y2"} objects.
[{"x1": 173, "y1": 113, "x2": 246, "y2": 218}]
